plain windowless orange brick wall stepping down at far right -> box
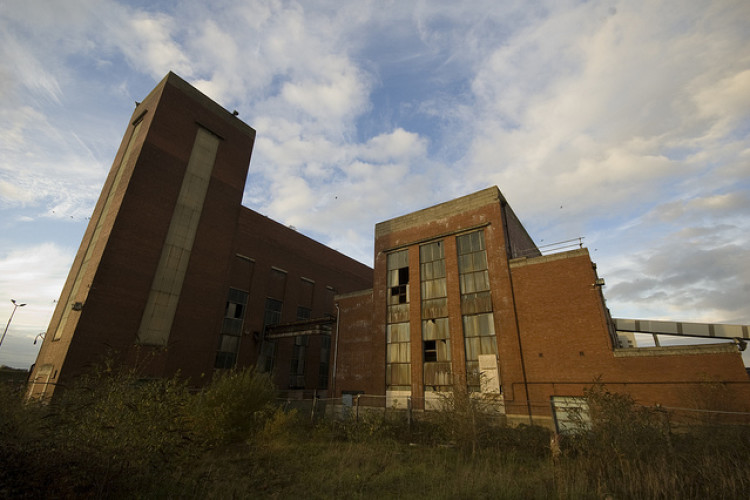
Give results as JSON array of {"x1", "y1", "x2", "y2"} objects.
[{"x1": 508, "y1": 250, "x2": 750, "y2": 422}]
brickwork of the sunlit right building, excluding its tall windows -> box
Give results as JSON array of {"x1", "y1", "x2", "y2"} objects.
[{"x1": 336, "y1": 188, "x2": 750, "y2": 425}]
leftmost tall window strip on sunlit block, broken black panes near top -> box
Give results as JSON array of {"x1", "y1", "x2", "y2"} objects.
[{"x1": 385, "y1": 250, "x2": 411, "y2": 391}]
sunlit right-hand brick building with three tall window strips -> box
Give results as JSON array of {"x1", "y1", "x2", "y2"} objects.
[{"x1": 333, "y1": 187, "x2": 750, "y2": 426}]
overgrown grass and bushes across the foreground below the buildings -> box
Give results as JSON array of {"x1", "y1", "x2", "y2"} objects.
[{"x1": 0, "y1": 374, "x2": 750, "y2": 499}]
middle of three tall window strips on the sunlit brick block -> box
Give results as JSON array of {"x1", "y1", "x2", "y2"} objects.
[{"x1": 419, "y1": 241, "x2": 453, "y2": 391}]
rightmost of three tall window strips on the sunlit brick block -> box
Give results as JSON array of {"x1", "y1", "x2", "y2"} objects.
[{"x1": 456, "y1": 230, "x2": 497, "y2": 391}]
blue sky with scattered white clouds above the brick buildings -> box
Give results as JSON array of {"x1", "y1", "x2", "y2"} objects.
[{"x1": 0, "y1": 0, "x2": 750, "y2": 367}]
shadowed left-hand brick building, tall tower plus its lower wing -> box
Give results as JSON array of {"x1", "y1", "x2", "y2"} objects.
[{"x1": 31, "y1": 73, "x2": 372, "y2": 396}]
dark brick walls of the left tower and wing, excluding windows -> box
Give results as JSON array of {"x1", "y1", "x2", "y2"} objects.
[{"x1": 29, "y1": 74, "x2": 372, "y2": 394}]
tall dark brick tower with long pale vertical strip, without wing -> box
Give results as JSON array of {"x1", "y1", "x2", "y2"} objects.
[{"x1": 30, "y1": 73, "x2": 255, "y2": 396}]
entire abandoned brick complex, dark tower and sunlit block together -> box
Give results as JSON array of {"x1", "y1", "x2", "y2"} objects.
[{"x1": 29, "y1": 73, "x2": 750, "y2": 425}]
